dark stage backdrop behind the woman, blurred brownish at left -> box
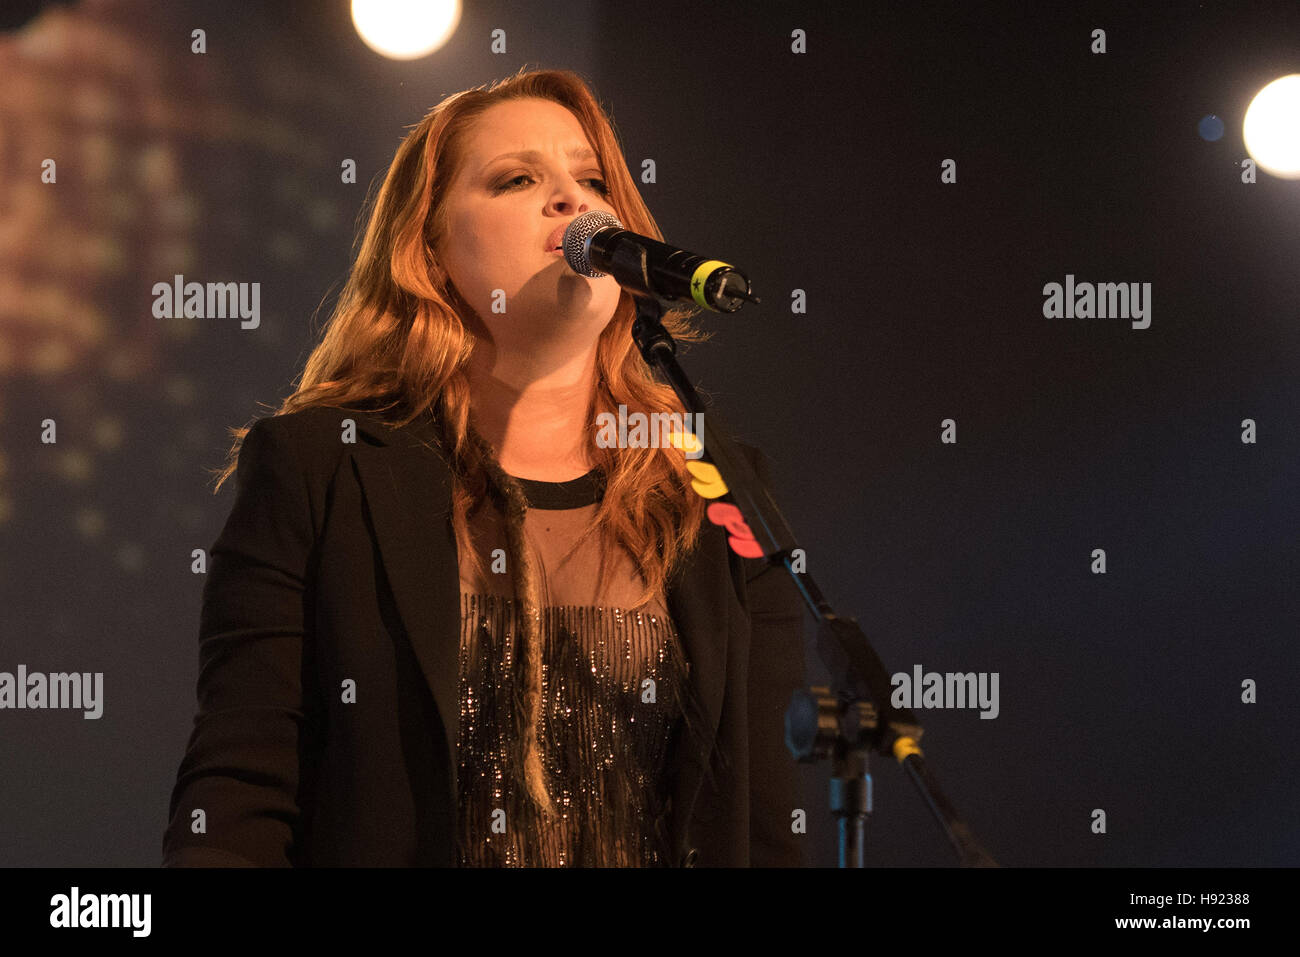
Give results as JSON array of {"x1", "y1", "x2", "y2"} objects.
[{"x1": 0, "y1": 0, "x2": 1300, "y2": 866}]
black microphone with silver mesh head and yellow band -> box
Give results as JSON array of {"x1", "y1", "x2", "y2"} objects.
[{"x1": 564, "y1": 209, "x2": 759, "y2": 312}]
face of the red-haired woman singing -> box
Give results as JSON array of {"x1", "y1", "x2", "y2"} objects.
[{"x1": 436, "y1": 99, "x2": 620, "y2": 352}]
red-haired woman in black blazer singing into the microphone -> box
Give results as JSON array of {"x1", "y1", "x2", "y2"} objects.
[{"x1": 164, "y1": 72, "x2": 805, "y2": 866}]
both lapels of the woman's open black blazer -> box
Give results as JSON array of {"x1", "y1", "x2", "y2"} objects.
[{"x1": 351, "y1": 403, "x2": 732, "y2": 863}]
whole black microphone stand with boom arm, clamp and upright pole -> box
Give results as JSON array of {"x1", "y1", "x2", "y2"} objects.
[{"x1": 628, "y1": 289, "x2": 998, "y2": 867}]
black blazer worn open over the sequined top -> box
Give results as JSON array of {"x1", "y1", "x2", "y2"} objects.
[{"x1": 163, "y1": 407, "x2": 806, "y2": 867}]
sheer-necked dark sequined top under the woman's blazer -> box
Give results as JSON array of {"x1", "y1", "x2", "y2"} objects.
[{"x1": 458, "y1": 462, "x2": 690, "y2": 867}]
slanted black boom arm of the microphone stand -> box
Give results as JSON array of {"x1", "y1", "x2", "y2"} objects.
[{"x1": 632, "y1": 295, "x2": 997, "y2": 867}]
